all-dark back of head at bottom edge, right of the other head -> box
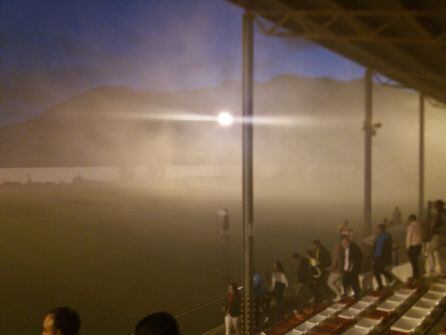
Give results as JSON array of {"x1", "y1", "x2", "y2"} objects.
[{"x1": 134, "y1": 312, "x2": 180, "y2": 335}]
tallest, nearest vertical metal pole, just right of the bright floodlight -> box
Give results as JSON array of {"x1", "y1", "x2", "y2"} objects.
[{"x1": 242, "y1": 12, "x2": 254, "y2": 335}]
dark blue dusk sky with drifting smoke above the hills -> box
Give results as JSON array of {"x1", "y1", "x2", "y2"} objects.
[{"x1": 0, "y1": 0, "x2": 363, "y2": 122}]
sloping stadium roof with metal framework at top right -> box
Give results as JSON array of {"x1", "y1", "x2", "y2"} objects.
[{"x1": 229, "y1": 0, "x2": 446, "y2": 103}]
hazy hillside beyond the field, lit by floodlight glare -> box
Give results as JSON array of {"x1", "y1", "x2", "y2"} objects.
[{"x1": 0, "y1": 76, "x2": 446, "y2": 205}]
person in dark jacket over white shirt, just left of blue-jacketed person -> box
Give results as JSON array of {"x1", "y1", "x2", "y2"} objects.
[{"x1": 341, "y1": 236, "x2": 362, "y2": 299}]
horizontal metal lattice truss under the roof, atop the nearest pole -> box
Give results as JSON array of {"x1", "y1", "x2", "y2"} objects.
[{"x1": 251, "y1": 10, "x2": 446, "y2": 45}]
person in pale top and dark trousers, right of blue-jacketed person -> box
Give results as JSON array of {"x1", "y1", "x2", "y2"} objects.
[{"x1": 406, "y1": 214, "x2": 423, "y2": 279}]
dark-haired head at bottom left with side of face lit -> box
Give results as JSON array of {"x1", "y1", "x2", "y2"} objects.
[{"x1": 42, "y1": 307, "x2": 81, "y2": 335}]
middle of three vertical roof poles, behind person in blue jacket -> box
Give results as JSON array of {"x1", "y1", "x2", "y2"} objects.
[{"x1": 364, "y1": 69, "x2": 373, "y2": 236}]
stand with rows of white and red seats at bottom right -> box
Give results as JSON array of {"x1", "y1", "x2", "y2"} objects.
[{"x1": 265, "y1": 278, "x2": 446, "y2": 335}]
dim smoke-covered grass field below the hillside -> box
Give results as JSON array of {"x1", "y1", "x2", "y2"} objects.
[{"x1": 0, "y1": 185, "x2": 370, "y2": 335}]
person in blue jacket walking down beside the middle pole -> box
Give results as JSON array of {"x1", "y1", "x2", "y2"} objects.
[{"x1": 373, "y1": 224, "x2": 393, "y2": 289}]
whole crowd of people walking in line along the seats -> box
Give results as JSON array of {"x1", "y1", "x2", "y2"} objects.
[{"x1": 225, "y1": 200, "x2": 446, "y2": 335}]
